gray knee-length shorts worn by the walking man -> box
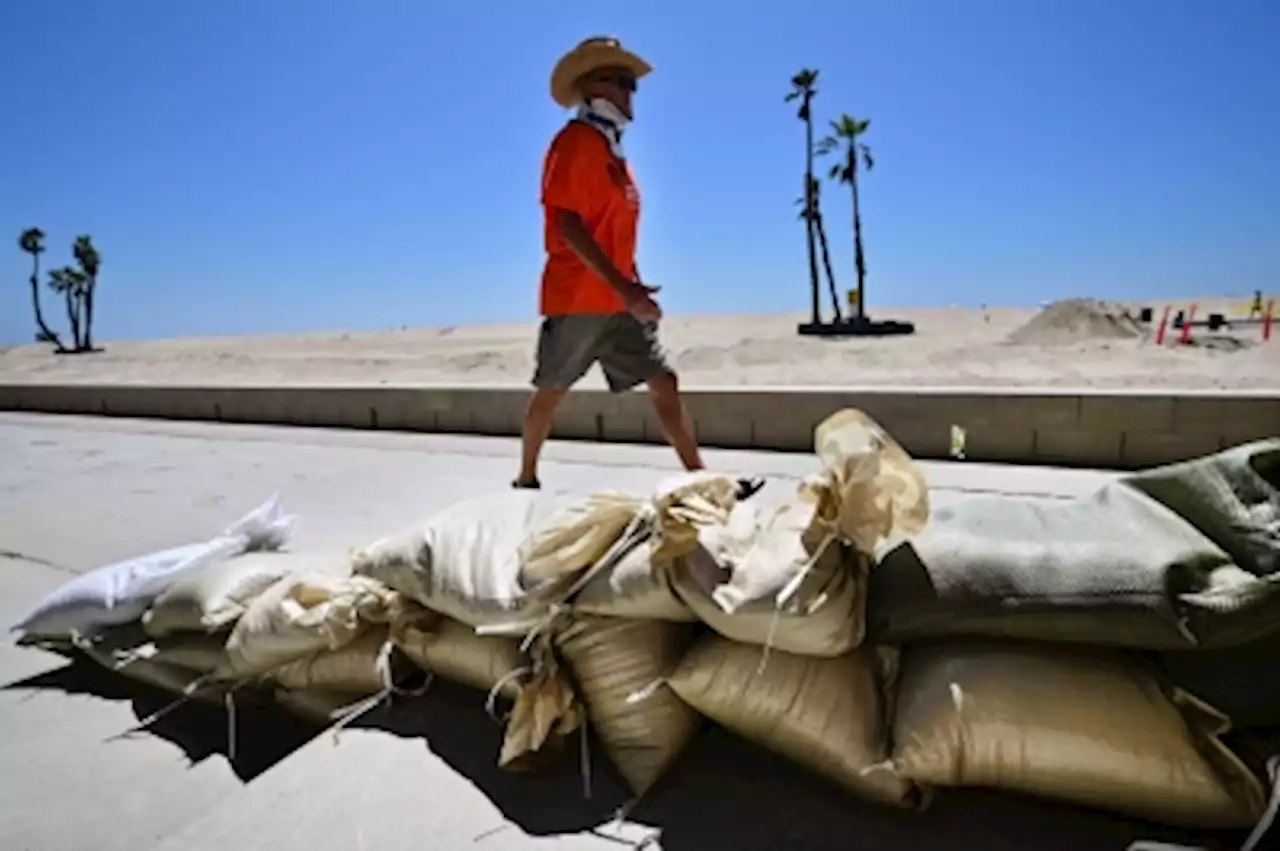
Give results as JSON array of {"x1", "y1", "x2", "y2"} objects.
[{"x1": 534, "y1": 314, "x2": 671, "y2": 393}]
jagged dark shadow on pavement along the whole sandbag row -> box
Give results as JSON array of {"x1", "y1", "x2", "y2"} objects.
[{"x1": 4, "y1": 659, "x2": 1243, "y2": 851}]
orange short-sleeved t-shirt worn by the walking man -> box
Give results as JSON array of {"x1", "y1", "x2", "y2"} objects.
[{"x1": 539, "y1": 122, "x2": 640, "y2": 316}]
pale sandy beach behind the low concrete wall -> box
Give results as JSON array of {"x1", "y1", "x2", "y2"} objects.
[{"x1": 0, "y1": 297, "x2": 1280, "y2": 390}]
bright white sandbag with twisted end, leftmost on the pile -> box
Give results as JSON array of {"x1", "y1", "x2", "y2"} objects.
[{"x1": 13, "y1": 497, "x2": 294, "y2": 637}]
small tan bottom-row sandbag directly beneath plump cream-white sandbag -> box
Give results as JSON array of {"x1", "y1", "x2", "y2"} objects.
[{"x1": 393, "y1": 616, "x2": 527, "y2": 699}]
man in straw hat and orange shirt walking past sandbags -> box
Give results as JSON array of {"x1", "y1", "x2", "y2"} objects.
[{"x1": 512, "y1": 37, "x2": 759, "y2": 495}]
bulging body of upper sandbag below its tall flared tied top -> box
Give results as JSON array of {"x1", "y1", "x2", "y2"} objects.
[{"x1": 671, "y1": 502, "x2": 869, "y2": 656}]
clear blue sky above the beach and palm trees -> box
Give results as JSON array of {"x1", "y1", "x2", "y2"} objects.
[{"x1": 0, "y1": 0, "x2": 1280, "y2": 343}]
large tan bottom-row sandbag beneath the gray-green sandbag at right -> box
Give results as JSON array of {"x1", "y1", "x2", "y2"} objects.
[{"x1": 893, "y1": 641, "x2": 1265, "y2": 828}]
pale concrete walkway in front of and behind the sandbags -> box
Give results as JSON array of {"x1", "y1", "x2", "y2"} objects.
[{"x1": 0, "y1": 415, "x2": 1198, "y2": 851}]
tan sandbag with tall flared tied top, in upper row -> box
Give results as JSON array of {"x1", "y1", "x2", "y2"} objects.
[{"x1": 673, "y1": 410, "x2": 928, "y2": 656}]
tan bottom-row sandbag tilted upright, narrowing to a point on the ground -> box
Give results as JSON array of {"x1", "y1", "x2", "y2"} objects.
[{"x1": 556, "y1": 617, "x2": 699, "y2": 795}]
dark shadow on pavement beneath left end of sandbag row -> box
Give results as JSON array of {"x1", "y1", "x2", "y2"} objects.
[{"x1": 4, "y1": 655, "x2": 316, "y2": 782}]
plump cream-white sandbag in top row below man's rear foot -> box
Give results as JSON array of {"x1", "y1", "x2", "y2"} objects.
[{"x1": 353, "y1": 490, "x2": 554, "y2": 627}]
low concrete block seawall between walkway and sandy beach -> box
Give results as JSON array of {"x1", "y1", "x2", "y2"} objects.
[{"x1": 0, "y1": 384, "x2": 1280, "y2": 468}]
